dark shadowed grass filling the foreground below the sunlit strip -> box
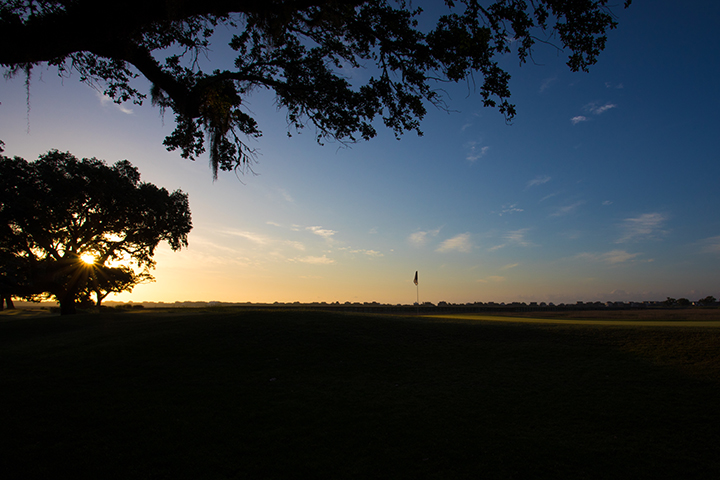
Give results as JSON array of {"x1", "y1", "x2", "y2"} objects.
[{"x1": 0, "y1": 310, "x2": 720, "y2": 479}]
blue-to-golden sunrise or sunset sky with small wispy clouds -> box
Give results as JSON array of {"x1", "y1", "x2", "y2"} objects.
[{"x1": 0, "y1": 0, "x2": 720, "y2": 304}]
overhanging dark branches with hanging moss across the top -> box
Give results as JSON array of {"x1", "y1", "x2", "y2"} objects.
[{"x1": 0, "y1": 0, "x2": 630, "y2": 175}]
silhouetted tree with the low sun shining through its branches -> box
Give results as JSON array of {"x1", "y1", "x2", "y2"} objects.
[{"x1": 0, "y1": 150, "x2": 192, "y2": 313}]
